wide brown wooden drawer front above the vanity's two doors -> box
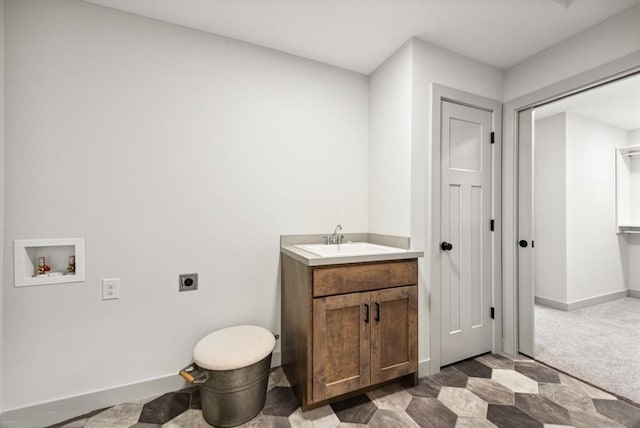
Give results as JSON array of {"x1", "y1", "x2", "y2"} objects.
[{"x1": 313, "y1": 260, "x2": 418, "y2": 297}]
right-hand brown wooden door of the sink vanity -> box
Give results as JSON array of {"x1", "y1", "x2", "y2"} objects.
[{"x1": 371, "y1": 285, "x2": 418, "y2": 383}]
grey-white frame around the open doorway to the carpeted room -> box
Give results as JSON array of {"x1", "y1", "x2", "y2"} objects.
[{"x1": 502, "y1": 52, "x2": 640, "y2": 354}]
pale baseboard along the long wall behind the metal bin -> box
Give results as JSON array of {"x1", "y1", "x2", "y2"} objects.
[{"x1": 0, "y1": 350, "x2": 282, "y2": 428}]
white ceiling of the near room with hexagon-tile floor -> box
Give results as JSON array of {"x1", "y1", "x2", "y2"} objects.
[{"x1": 85, "y1": 0, "x2": 640, "y2": 74}]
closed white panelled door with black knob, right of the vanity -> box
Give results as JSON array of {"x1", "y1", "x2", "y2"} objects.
[{"x1": 440, "y1": 101, "x2": 492, "y2": 366}]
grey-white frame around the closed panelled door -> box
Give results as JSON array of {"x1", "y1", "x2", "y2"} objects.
[{"x1": 428, "y1": 83, "x2": 503, "y2": 374}]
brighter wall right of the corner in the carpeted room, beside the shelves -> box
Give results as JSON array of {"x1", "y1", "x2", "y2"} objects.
[{"x1": 567, "y1": 114, "x2": 628, "y2": 302}]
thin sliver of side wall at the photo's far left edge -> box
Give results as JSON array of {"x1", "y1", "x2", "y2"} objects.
[{"x1": 0, "y1": 0, "x2": 6, "y2": 413}]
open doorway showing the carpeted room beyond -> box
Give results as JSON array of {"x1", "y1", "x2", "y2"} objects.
[{"x1": 519, "y1": 74, "x2": 640, "y2": 402}]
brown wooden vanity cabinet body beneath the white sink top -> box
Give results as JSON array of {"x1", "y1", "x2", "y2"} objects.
[{"x1": 281, "y1": 255, "x2": 418, "y2": 410}]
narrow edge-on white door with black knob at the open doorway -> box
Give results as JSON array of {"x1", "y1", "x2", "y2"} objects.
[{"x1": 515, "y1": 109, "x2": 535, "y2": 357}]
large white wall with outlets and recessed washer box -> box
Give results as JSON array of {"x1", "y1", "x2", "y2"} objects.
[{"x1": 3, "y1": 0, "x2": 368, "y2": 410}]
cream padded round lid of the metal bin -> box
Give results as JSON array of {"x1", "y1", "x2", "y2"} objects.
[{"x1": 193, "y1": 325, "x2": 276, "y2": 370}]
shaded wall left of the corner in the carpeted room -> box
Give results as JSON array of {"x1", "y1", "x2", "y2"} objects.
[{"x1": 533, "y1": 113, "x2": 567, "y2": 303}]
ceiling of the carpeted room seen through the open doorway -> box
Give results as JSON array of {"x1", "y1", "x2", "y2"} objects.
[{"x1": 536, "y1": 74, "x2": 640, "y2": 130}]
